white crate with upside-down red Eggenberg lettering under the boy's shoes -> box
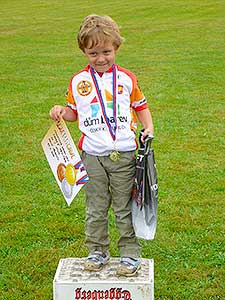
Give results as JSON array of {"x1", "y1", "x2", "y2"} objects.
[{"x1": 53, "y1": 258, "x2": 154, "y2": 300}]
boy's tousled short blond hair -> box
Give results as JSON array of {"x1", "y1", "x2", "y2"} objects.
[{"x1": 77, "y1": 15, "x2": 124, "y2": 51}]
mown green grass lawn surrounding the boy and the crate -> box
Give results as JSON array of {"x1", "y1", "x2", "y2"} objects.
[{"x1": 0, "y1": 0, "x2": 225, "y2": 300}]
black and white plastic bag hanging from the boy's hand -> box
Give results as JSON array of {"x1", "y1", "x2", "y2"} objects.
[{"x1": 132, "y1": 131, "x2": 158, "y2": 240}]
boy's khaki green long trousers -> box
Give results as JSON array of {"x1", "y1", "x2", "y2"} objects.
[{"x1": 82, "y1": 151, "x2": 140, "y2": 257}]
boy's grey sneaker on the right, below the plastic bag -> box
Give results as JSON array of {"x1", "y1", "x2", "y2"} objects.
[{"x1": 116, "y1": 257, "x2": 141, "y2": 277}]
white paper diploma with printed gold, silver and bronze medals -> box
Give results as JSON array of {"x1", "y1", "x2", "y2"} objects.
[{"x1": 41, "y1": 118, "x2": 88, "y2": 205}]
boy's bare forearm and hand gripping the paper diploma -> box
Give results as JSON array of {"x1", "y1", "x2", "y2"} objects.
[{"x1": 49, "y1": 105, "x2": 77, "y2": 122}]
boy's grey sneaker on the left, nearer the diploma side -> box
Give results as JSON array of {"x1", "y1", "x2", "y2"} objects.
[{"x1": 84, "y1": 251, "x2": 109, "y2": 272}]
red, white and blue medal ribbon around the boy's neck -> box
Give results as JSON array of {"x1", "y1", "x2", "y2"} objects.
[{"x1": 91, "y1": 65, "x2": 117, "y2": 141}]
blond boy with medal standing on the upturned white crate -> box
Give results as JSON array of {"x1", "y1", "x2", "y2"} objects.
[{"x1": 50, "y1": 15, "x2": 153, "y2": 276}]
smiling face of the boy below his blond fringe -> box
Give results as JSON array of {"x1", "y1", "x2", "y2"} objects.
[{"x1": 84, "y1": 42, "x2": 117, "y2": 72}]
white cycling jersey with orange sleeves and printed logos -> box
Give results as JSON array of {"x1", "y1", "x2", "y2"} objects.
[{"x1": 66, "y1": 65, "x2": 147, "y2": 156}]
